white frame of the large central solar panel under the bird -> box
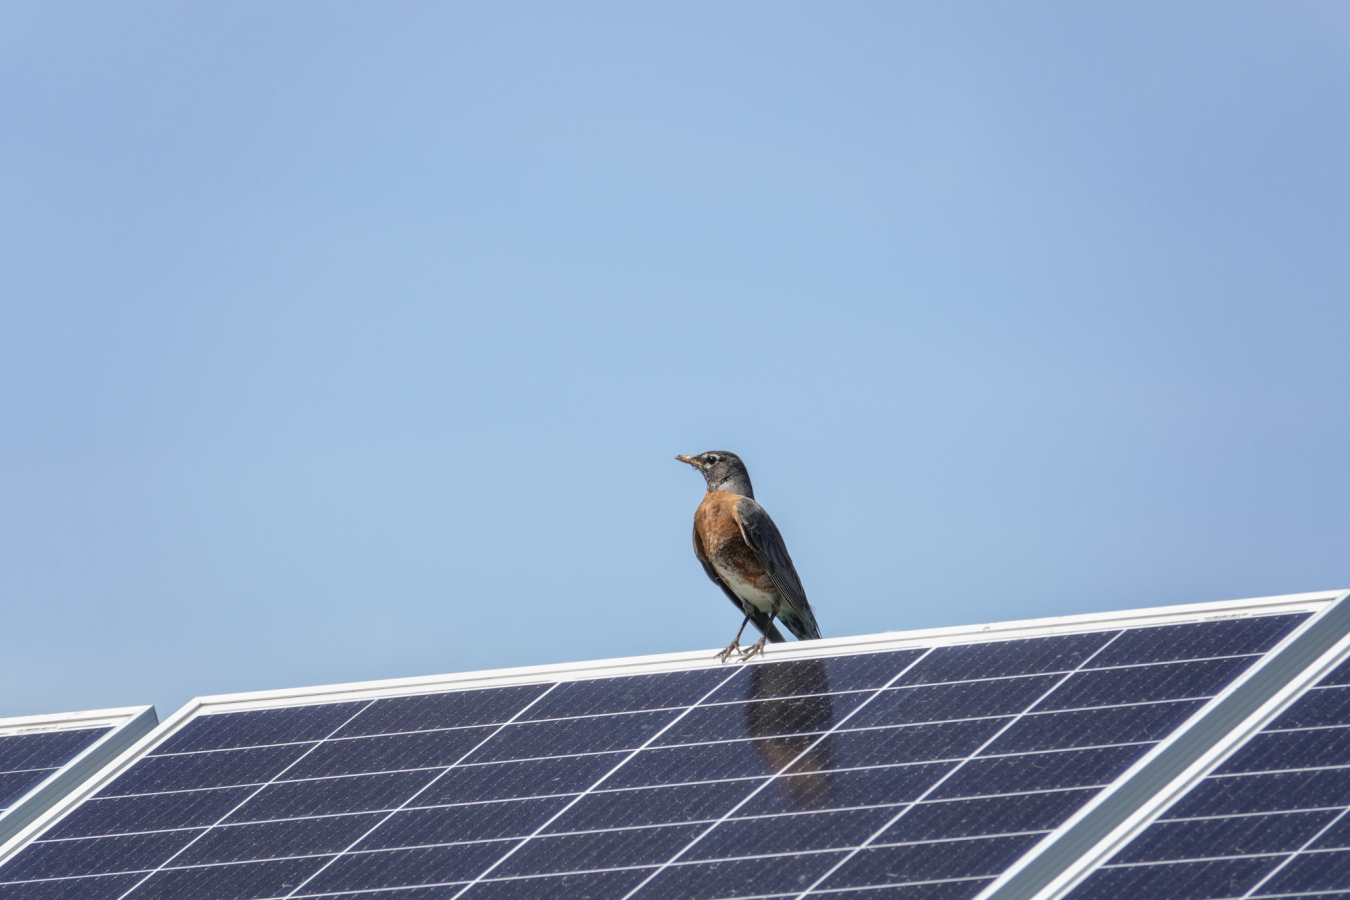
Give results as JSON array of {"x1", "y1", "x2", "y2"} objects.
[{"x1": 0, "y1": 591, "x2": 1350, "y2": 900}]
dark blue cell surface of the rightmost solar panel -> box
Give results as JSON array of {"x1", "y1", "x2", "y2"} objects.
[{"x1": 1069, "y1": 644, "x2": 1350, "y2": 900}]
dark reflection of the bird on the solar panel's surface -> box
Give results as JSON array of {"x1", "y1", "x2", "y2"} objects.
[{"x1": 745, "y1": 660, "x2": 834, "y2": 808}]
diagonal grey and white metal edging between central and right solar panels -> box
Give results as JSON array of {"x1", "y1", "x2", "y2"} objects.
[{"x1": 975, "y1": 591, "x2": 1350, "y2": 900}]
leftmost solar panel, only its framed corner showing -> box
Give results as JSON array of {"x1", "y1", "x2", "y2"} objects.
[{"x1": 0, "y1": 707, "x2": 157, "y2": 853}]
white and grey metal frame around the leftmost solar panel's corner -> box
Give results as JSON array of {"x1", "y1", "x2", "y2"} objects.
[{"x1": 0, "y1": 706, "x2": 159, "y2": 860}]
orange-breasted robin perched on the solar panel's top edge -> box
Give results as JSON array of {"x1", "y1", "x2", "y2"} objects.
[{"x1": 675, "y1": 451, "x2": 821, "y2": 663}]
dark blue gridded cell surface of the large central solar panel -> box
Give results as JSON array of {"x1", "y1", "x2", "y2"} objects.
[{"x1": 0, "y1": 615, "x2": 1306, "y2": 900}]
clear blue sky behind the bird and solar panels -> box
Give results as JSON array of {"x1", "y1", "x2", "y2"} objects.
[{"x1": 0, "y1": 0, "x2": 1350, "y2": 715}]
